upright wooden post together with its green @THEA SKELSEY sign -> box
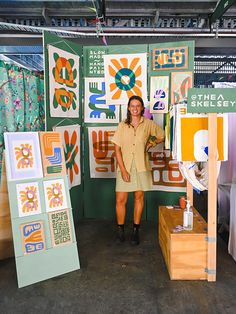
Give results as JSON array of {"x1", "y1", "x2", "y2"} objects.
[{"x1": 187, "y1": 88, "x2": 236, "y2": 282}]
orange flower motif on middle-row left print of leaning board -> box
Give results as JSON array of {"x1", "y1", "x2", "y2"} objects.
[{"x1": 20, "y1": 186, "x2": 39, "y2": 213}]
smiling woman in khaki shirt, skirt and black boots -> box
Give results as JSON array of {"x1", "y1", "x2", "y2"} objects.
[{"x1": 112, "y1": 96, "x2": 164, "y2": 245}]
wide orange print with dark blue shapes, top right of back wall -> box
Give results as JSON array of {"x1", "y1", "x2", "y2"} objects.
[{"x1": 152, "y1": 47, "x2": 188, "y2": 71}]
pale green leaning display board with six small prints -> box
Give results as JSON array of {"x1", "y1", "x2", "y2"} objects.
[{"x1": 4, "y1": 132, "x2": 80, "y2": 288}]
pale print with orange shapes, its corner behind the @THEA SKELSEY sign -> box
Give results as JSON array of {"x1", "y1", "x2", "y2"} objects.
[{"x1": 171, "y1": 72, "x2": 193, "y2": 104}]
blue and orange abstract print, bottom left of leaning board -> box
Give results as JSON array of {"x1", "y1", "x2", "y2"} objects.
[{"x1": 20, "y1": 221, "x2": 46, "y2": 254}]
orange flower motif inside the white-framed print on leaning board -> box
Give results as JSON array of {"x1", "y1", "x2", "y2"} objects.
[{"x1": 15, "y1": 143, "x2": 34, "y2": 169}]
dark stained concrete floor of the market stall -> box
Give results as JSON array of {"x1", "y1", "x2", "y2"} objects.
[{"x1": 0, "y1": 220, "x2": 236, "y2": 314}]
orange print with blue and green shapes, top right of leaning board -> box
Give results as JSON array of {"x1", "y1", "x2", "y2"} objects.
[{"x1": 39, "y1": 132, "x2": 66, "y2": 177}]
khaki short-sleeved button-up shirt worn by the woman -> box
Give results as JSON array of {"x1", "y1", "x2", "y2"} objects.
[{"x1": 111, "y1": 117, "x2": 164, "y2": 172}]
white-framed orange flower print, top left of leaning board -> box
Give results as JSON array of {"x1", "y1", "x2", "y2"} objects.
[{"x1": 4, "y1": 132, "x2": 43, "y2": 180}]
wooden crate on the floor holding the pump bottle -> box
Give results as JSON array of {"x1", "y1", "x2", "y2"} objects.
[{"x1": 159, "y1": 206, "x2": 207, "y2": 280}]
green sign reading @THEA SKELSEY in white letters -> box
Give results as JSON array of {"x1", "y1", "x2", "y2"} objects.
[{"x1": 187, "y1": 88, "x2": 236, "y2": 113}]
